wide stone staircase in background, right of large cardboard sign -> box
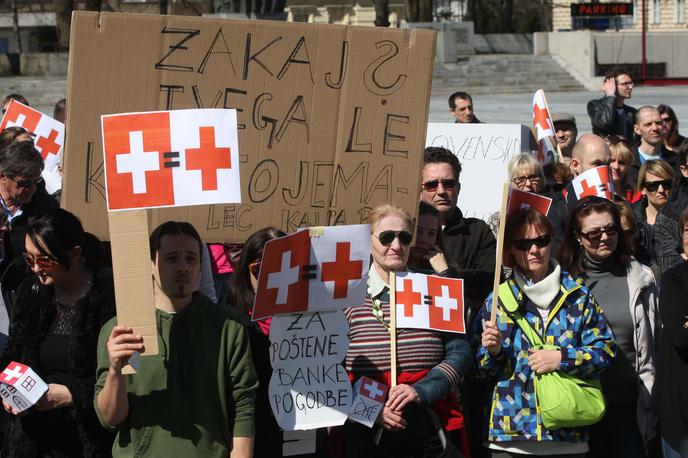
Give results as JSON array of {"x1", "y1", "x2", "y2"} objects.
[{"x1": 432, "y1": 54, "x2": 585, "y2": 97}]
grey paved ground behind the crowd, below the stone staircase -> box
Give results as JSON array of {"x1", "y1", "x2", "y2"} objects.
[{"x1": 430, "y1": 86, "x2": 688, "y2": 135}]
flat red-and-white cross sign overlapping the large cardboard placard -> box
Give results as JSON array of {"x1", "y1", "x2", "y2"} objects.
[{"x1": 101, "y1": 109, "x2": 241, "y2": 210}]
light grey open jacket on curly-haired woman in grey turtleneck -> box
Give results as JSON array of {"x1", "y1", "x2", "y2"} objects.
[{"x1": 626, "y1": 260, "x2": 662, "y2": 441}]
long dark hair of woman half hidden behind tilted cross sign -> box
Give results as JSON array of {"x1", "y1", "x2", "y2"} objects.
[{"x1": 227, "y1": 227, "x2": 287, "y2": 314}]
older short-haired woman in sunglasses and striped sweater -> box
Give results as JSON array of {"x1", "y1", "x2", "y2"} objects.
[{"x1": 345, "y1": 205, "x2": 471, "y2": 457}]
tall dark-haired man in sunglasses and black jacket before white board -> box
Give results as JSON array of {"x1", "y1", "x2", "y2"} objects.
[{"x1": 420, "y1": 146, "x2": 497, "y2": 318}]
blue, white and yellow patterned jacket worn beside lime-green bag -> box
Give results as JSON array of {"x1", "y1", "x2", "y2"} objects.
[{"x1": 472, "y1": 271, "x2": 616, "y2": 442}]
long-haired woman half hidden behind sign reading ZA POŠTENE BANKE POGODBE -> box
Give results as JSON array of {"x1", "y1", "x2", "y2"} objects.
[{"x1": 226, "y1": 227, "x2": 286, "y2": 457}]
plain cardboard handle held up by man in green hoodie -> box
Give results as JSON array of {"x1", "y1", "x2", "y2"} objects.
[{"x1": 109, "y1": 210, "x2": 158, "y2": 356}]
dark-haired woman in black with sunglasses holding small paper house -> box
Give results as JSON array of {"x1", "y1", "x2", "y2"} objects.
[{"x1": 0, "y1": 209, "x2": 115, "y2": 457}]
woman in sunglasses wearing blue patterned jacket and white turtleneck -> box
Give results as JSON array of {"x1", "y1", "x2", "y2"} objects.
[{"x1": 472, "y1": 208, "x2": 614, "y2": 458}]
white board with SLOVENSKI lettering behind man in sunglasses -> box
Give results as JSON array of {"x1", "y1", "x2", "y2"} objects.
[{"x1": 425, "y1": 123, "x2": 537, "y2": 221}]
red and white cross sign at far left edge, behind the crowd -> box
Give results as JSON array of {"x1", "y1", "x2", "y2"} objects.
[{"x1": 0, "y1": 99, "x2": 65, "y2": 194}]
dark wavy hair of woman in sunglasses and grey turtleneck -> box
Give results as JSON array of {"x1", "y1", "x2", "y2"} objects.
[{"x1": 558, "y1": 196, "x2": 633, "y2": 277}]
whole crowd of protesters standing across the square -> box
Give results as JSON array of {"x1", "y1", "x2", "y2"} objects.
[{"x1": 0, "y1": 69, "x2": 688, "y2": 458}]
